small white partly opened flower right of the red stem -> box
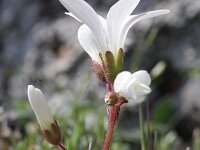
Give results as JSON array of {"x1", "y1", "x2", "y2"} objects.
[{"x1": 114, "y1": 70, "x2": 151, "y2": 102}]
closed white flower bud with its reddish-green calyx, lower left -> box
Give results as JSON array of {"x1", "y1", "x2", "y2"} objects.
[{"x1": 27, "y1": 85, "x2": 61, "y2": 145}]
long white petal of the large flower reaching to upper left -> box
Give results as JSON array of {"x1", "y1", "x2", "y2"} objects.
[{"x1": 59, "y1": 0, "x2": 107, "y2": 49}]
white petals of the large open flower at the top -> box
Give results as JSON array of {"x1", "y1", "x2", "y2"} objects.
[{"x1": 60, "y1": 0, "x2": 169, "y2": 62}]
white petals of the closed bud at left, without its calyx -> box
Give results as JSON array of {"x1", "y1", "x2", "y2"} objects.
[{"x1": 27, "y1": 85, "x2": 55, "y2": 130}]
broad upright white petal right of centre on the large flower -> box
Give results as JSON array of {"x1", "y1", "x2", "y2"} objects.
[{"x1": 107, "y1": 0, "x2": 140, "y2": 52}]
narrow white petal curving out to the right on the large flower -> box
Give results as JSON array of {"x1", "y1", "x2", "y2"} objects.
[{"x1": 119, "y1": 10, "x2": 169, "y2": 48}]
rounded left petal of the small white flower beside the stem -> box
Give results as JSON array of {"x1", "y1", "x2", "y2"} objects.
[{"x1": 114, "y1": 71, "x2": 131, "y2": 96}]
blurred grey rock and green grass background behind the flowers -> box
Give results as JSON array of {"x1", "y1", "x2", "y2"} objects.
[{"x1": 0, "y1": 0, "x2": 200, "y2": 150}]
